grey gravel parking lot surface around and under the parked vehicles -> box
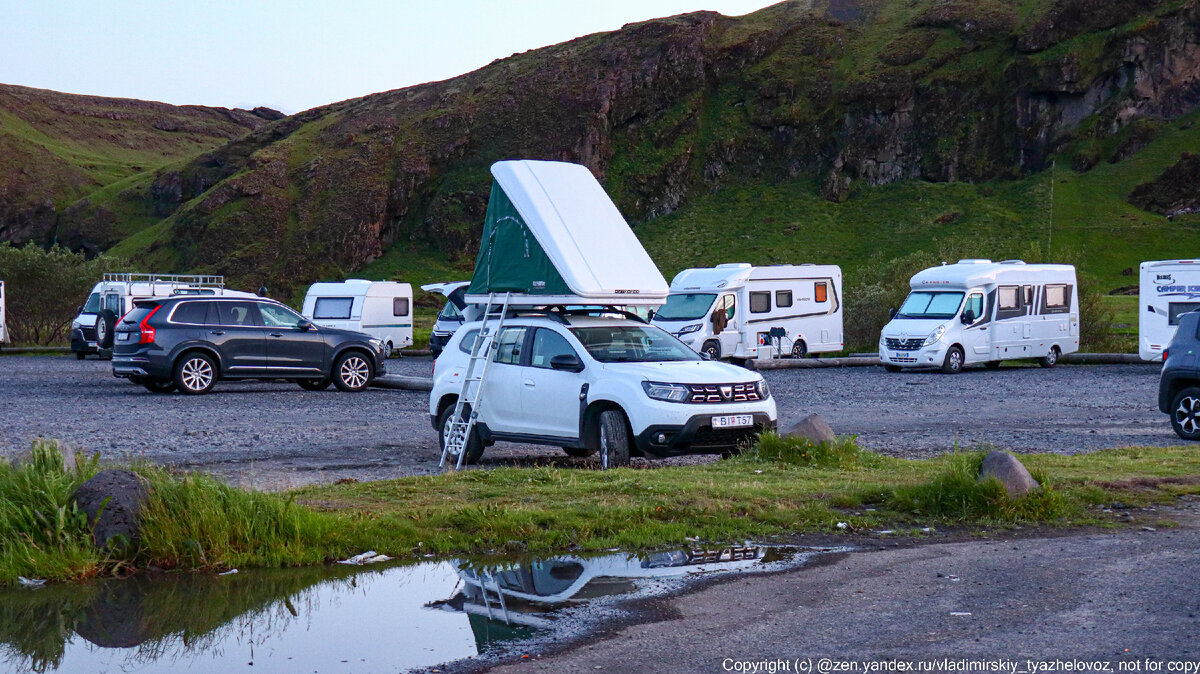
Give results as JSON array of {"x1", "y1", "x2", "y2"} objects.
[{"x1": 0, "y1": 356, "x2": 1181, "y2": 488}]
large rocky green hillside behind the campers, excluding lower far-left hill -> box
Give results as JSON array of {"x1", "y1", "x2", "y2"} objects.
[{"x1": 2, "y1": 0, "x2": 1200, "y2": 303}]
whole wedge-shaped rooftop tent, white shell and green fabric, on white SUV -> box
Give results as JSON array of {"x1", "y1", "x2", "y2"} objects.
[{"x1": 467, "y1": 160, "x2": 668, "y2": 305}]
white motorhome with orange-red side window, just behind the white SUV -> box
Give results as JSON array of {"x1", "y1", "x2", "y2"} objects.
[{"x1": 654, "y1": 263, "x2": 842, "y2": 360}]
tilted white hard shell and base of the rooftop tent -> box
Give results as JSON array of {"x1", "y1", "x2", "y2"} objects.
[{"x1": 467, "y1": 160, "x2": 668, "y2": 305}]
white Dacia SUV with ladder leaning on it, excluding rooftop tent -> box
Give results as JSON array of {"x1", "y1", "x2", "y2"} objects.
[{"x1": 430, "y1": 312, "x2": 776, "y2": 468}]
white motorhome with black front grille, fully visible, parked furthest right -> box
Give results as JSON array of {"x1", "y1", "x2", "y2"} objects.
[{"x1": 880, "y1": 260, "x2": 1079, "y2": 374}]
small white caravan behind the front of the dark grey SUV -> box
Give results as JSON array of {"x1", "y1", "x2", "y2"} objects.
[{"x1": 300, "y1": 278, "x2": 413, "y2": 355}]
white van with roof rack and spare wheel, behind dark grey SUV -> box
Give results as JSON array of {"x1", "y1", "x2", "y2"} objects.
[{"x1": 71, "y1": 273, "x2": 256, "y2": 360}]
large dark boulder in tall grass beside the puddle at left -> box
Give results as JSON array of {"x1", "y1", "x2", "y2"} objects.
[{"x1": 71, "y1": 470, "x2": 150, "y2": 549}]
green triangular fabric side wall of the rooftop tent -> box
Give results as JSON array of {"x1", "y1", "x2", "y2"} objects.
[{"x1": 467, "y1": 182, "x2": 574, "y2": 295}]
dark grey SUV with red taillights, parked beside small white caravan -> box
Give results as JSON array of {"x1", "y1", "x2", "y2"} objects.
[{"x1": 113, "y1": 297, "x2": 386, "y2": 393}]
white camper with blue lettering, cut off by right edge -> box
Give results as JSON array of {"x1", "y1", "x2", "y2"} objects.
[{"x1": 1138, "y1": 260, "x2": 1200, "y2": 361}]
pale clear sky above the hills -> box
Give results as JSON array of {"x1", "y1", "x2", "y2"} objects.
[{"x1": 0, "y1": 0, "x2": 773, "y2": 114}]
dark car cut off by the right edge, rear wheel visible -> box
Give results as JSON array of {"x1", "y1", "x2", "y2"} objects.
[{"x1": 1158, "y1": 312, "x2": 1200, "y2": 440}]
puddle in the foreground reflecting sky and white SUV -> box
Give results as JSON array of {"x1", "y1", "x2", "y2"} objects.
[{"x1": 0, "y1": 546, "x2": 840, "y2": 674}]
